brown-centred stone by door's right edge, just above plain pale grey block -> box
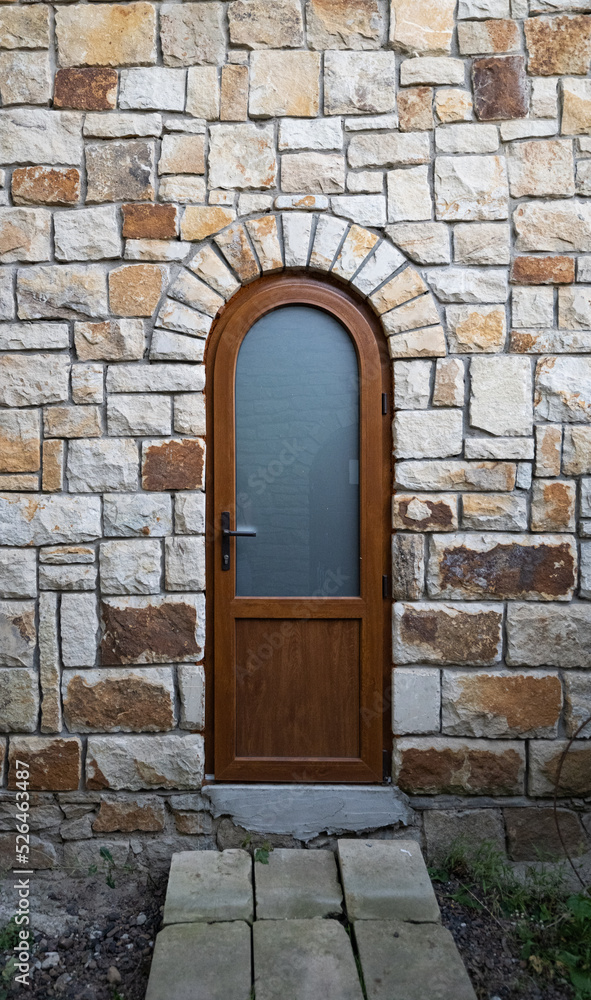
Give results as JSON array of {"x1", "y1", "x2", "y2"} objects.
[{"x1": 400, "y1": 604, "x2": 501, "y2": 665}]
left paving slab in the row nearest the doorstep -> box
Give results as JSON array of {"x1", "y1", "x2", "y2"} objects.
[{"x1": 163, "y1": 850, "x2": 254, "y2": 924}]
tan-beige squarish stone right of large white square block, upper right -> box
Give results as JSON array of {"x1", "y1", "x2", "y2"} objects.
[{"x1": 507, "y1": 139, "x2": 575, "y2": 198}]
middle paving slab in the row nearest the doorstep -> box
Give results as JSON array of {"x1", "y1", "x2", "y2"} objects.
[{"x1": 254, "y1": 848, "x2": 343, "y2": 920}]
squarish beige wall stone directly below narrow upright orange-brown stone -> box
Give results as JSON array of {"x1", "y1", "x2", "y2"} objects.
[{"x1": 209, "y1": 122, "x2": 277, "y2": 190}]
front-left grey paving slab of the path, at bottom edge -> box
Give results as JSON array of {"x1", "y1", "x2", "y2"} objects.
[{"x1": 146, "y1": 921, "x2": 252, "y2": 1000}]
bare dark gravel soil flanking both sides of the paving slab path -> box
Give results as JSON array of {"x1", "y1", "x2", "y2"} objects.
[{"x1": 0, "y1": 871, "x2": 573, "y2": 1000}]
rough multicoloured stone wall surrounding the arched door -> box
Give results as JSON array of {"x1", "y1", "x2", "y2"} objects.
[{"x1": 0, "y1": 0, "x2": 591, "y2": 863}]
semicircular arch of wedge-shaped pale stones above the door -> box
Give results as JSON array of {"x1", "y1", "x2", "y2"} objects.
[{"x1": 150, "y1": 211, "x2": 447, "y2": 361}]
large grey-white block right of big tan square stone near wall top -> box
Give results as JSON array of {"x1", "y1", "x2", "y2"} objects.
[{"x1": 324, "y1": 52, "x2": 396, "y2": 115}]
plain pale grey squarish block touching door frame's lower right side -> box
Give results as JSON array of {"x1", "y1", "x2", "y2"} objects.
[{"x1": 392, "y1": 667, "x2": 441, "y2": 736}]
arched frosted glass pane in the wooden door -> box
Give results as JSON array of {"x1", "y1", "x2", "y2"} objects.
[{"x1": 236, "y1": 306, "x2": 359, "y2": 597}]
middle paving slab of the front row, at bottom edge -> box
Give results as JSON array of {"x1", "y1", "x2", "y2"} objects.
[{"x1": 254, "y1": 917, "x2": 363, "y2": 1000}]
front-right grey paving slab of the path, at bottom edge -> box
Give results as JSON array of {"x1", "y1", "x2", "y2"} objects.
[{"x1": 356, "y1": 920, "x2": 476, "y2": 1000}]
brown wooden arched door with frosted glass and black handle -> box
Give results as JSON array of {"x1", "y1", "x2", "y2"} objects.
[{"x1": 207, "y1": 275, "x2": 391, "y2": 782}]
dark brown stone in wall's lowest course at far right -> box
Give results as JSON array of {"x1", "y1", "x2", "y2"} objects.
[{"x1": 504, "y1": 808, "x2": 587, "y2": 861}]
